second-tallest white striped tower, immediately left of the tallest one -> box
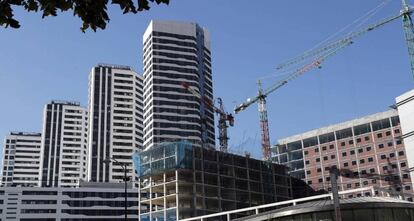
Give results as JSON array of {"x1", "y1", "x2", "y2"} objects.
[{"x1": 88, "y1": 64, "x2": 142, "y2": 182}]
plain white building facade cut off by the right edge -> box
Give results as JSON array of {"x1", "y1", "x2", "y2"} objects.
[{"x1": 395, "y1": 90, "x2": 414, "y2": 183}]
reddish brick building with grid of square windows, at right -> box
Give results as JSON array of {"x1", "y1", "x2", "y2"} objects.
[{"x1": 272, "y1": 110, "x2": 412, "y2": 197}]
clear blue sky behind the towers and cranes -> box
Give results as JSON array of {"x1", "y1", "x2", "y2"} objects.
[{"x1": 0, "y1": 0, "x2": 414, "y2": 157}]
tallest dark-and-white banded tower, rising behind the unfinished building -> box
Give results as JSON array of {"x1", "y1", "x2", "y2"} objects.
[{"x1": 143, "y1": 21, "x2": 215, "y2": 149}]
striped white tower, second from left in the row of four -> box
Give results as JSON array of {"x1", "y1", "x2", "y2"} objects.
[{"x1": 41, "y1": 101, "x2": 88, "y2": 187}]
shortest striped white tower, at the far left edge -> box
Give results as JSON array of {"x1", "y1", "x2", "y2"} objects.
[{"x1": 1, "y1": 132, "x2": 42, "y2": 186}]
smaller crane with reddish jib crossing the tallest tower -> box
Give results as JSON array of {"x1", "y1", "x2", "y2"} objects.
[{"x1": 181, "y1": 82, "x2": 234, "y2": 152}]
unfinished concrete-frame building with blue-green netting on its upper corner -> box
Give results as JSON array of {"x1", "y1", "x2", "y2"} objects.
[{"x1": 134, "y1": 141, "x2": 292, "y2": 221}]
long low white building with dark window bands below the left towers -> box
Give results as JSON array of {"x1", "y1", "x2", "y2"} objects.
[{"x1": 0, "y1": 183, "x2": 138, "y2": 221}]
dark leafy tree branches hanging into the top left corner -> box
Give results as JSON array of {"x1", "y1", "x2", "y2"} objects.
[{"x1": 0, "y1": 0, "x2": 169, "y2": 32}]
